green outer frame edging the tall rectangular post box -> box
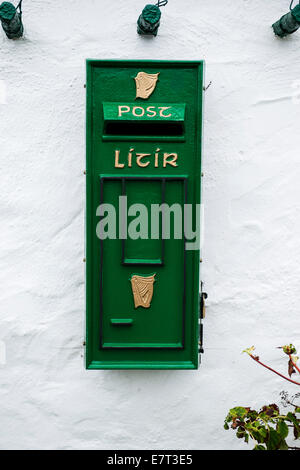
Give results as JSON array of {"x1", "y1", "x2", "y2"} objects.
[{"x1": 85, "y1": 59, "x2": 205, "y2": 369}]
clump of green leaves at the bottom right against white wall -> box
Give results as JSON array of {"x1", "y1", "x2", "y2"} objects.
[{"x1": 224, "y1": 403, "x2": 300, "y2": 450}]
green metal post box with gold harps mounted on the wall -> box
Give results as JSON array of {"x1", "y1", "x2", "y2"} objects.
[{"x1": 86, "y1": 60, "x2": 204, "y2": 369}]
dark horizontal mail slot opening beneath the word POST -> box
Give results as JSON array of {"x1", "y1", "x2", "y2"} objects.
[{"x1": 104, "y1": 121, "x2": 184, "y2": 137}]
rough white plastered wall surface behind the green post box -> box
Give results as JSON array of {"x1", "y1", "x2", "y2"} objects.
[{"x1": 0, "y1": 0, "x2": 300, "y2": 449}]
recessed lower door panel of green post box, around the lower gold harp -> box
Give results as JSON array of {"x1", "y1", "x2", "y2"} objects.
[{"x1": 101, "y1": 176, "x2": 185, "y2": 348}]
